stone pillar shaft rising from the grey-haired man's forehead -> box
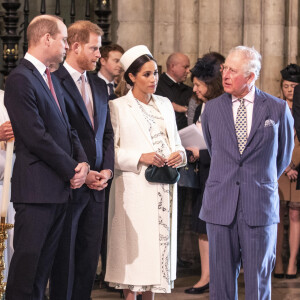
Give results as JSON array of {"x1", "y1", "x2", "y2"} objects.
[{"x1": 220, "y1": 0, "x2": 244, "y2": 56}]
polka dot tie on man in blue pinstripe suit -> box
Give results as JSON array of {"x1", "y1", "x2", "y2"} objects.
[{"x1": 235, "y1": 99, "x2": 247, "y2": 155}]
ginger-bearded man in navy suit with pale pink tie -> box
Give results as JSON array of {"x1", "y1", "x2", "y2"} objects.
[{"x1": 50, "y1": 21, "x2": 114, "y2": 300}]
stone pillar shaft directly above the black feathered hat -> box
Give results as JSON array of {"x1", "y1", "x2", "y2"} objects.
[{"x1": 197, "y1": 0, "x2": 221, "y2": 57}]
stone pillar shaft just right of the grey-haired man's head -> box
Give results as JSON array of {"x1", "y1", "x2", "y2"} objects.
[{"x1": 261, "y1": 0, "x2": 286, "y2": 96}]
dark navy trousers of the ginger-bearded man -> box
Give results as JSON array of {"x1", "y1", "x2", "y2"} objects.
[{"x1": 50, "y1": 195, "x2": 104, "y2": 300}]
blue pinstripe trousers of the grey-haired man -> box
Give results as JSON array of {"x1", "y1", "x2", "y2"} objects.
[{"x1": 206, "y1": 202, "x2": 277, "y2": 300}]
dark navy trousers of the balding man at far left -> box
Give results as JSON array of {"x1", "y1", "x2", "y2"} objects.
[{"x1": 5, "y1": 203, "x2": 67, "y2": 300}]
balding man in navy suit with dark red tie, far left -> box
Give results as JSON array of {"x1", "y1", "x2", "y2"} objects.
[{"x1": 4, "y1": 15, "x2": 89, "y2": 300}]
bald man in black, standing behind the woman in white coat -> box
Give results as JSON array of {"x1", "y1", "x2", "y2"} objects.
[{"x1": 155, "y1": 52, "x2": 193, "y2": 267}]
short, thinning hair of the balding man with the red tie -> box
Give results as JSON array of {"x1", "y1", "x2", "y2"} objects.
[{"x1": 27, "y1": 15, "x2": 62, "y2": 47}]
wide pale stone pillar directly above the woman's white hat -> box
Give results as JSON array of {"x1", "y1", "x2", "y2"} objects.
[{"x1": 113, "y1": 0, "x2": 153, "y2": 51}]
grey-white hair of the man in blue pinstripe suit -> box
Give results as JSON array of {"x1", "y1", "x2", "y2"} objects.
[{"x1": 229, "y1": 46, "x2": 261, "y2": 80}]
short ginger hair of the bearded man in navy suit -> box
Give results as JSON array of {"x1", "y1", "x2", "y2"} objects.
[{"x1": 68, "y1": 20, "x2": 103, "y2": 46}]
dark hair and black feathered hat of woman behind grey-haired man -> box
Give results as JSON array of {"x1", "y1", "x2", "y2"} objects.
[{"x1": 191, "y1": 52, "x2": 224, "y2": 100}]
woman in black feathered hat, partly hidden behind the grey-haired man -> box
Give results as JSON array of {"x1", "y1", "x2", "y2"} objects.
[{"x1": 185, "y1": 52, "x2": 225, "y2": 294}]
